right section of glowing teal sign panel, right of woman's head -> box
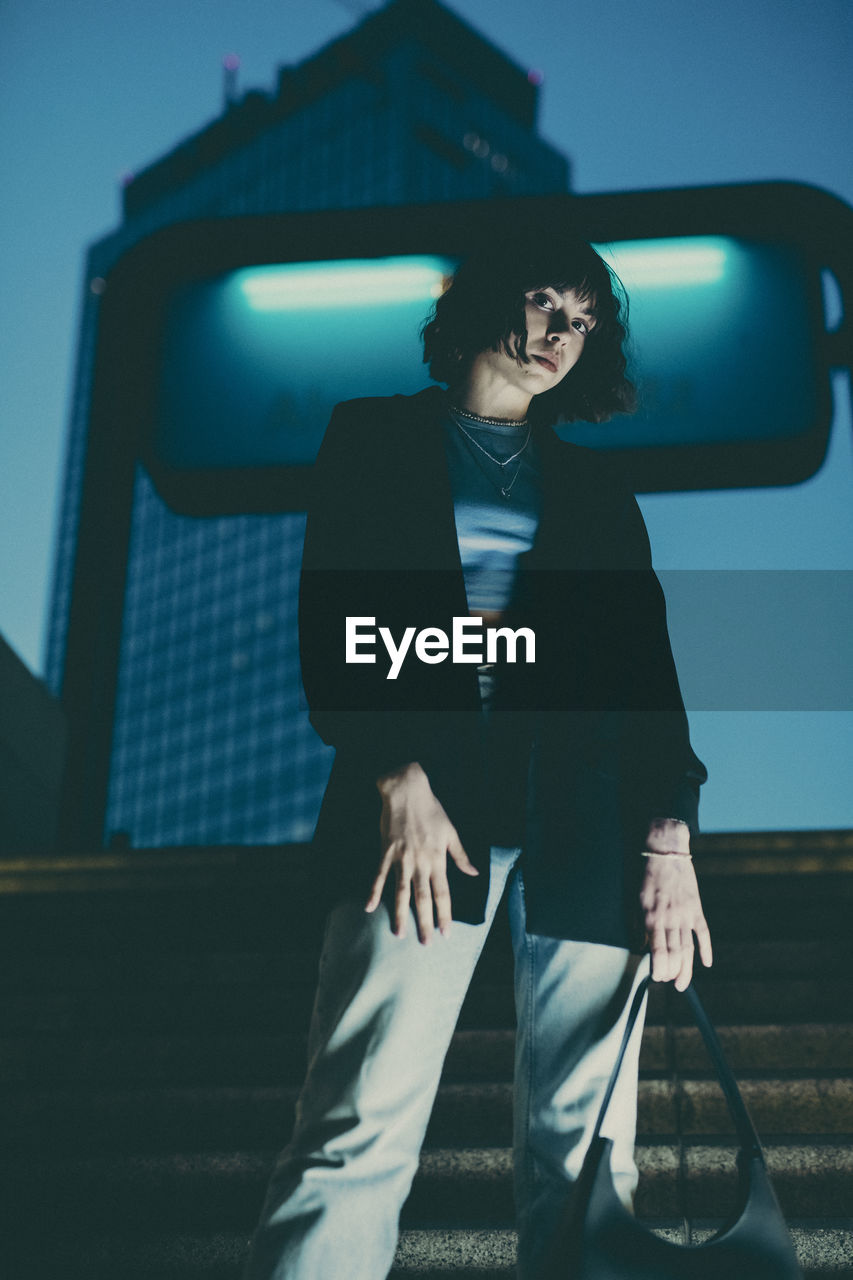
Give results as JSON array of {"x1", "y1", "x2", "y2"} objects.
[{"x1": 550, "y1": 236, "x2": 817, "y2": 448}]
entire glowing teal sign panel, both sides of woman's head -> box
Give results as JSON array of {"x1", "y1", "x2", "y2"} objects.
[{"x1": 155, "y1": 237, "x2": 817, "y2": 470}]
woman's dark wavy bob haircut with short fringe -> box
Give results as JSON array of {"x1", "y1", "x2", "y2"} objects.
[{"x1": 420, "y1": 239, "x2": 637, "y2": 422}]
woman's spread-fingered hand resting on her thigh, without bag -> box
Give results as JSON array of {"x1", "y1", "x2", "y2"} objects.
[{"x1": 365, "y1": 762, "x2": 479, "y2": 945}]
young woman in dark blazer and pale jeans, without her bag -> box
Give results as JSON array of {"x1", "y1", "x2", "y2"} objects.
[{"x1": 247, "y1": 242, "x2": 711, "y2": 1280}]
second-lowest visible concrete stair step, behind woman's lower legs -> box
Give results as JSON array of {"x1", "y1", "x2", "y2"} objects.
[{"x1": 4, "y1": 1143, "x2": 853, "y2": 1236}]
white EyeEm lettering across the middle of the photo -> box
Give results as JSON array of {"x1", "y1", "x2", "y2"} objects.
[{"x1": 346, "y1": 617, "x2": 537, "y2": 680}]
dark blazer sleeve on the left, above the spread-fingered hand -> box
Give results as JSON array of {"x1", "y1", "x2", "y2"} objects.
[{"x1": 298, "y1": 401, "x2": 415, "y2": 777}]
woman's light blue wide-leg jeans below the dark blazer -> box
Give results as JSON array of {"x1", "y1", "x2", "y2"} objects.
[{"x1": 245, "y1": 847, "x2": 648, "y2": 1280}]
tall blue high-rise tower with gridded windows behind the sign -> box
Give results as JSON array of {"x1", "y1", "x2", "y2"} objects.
[{"x1": 46, "y1": 0, "x2": 569, "y2": 846}]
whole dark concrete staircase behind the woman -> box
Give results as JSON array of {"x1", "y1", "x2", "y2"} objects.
[{"x1": 0, "y1": 832, "x2": 853, "y2": 1280}]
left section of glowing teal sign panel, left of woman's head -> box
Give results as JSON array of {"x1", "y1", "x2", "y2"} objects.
[{"x1": 156, "y1": 257, "x2": 456, "y2": 468}]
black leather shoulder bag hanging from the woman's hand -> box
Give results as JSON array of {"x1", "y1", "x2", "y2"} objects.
[{"x1": 547, "y1": 979, "x2": 803, "y2": 1280}]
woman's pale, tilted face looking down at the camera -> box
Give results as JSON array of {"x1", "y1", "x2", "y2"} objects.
[{"x1": 475, "y1": 285, "x2": 596, "y2": 396}]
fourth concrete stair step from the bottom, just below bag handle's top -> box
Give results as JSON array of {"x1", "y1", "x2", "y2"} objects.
[{"x1": 6, "y1": 1023, "x2": 853, "y2": 1087}]
